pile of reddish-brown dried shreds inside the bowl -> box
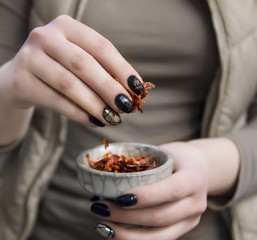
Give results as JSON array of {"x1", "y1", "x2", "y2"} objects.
[{"x1": 86, "y1": 152, "x2": 156, "y2": 173}]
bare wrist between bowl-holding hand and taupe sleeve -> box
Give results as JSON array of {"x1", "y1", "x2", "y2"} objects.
[{"x1": 189, "y1": 138, "x2": 240, "y2": 196}]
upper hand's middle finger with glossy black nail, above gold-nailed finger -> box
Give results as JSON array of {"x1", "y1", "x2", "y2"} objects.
[{"x1": 40, "y1": 34, "x2": 134, "y2": 113}]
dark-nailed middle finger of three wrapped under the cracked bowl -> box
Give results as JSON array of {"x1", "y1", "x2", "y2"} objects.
[{"x1": 91, "y1": 197, "x2": 206, "y2": 226}]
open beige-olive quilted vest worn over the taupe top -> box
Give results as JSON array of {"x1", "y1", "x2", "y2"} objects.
[{"x1": 0, "y1": 0, "x2": 257, "y2": 240}]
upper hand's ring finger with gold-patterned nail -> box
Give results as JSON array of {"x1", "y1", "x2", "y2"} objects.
[{"x1": 28, "y1": 51, "x2": 120, "y2": 124}]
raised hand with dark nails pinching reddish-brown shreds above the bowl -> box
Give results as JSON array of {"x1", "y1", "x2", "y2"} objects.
[{"x1": 1, "y1": 16, "x2": 144, "y2": 126}]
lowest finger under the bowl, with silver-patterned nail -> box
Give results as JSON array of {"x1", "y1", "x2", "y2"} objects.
[{"x1": 96, "y1": 217, "x2": 200, "y2": 240}]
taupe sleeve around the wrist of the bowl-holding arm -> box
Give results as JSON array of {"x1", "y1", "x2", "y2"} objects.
[{"x1": 209, "y1": 94, "x2": 257, "y2": 210}]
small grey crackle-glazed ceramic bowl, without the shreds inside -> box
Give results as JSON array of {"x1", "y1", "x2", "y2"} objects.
[{"x1": 76, "y1": 143, "x2": 174, "y2": 199}]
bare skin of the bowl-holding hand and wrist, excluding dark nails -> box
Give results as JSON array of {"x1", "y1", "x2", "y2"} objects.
[{"x1": 95, "y1": 138, "x2": 239, "y2": 240}]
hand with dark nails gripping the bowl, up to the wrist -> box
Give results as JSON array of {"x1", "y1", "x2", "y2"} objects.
[{"x1": 91, "y1": 143, "x2": 208, "y2": 240}]
